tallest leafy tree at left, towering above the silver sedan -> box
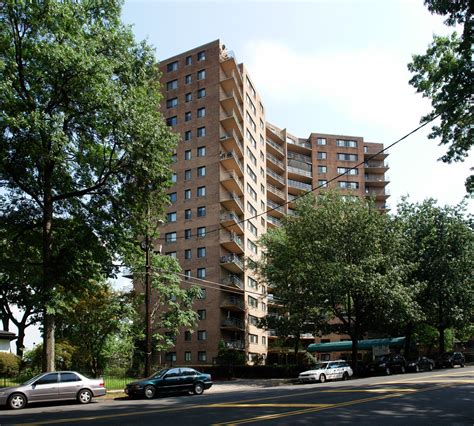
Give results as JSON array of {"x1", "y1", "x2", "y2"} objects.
[{"x1": 0, "y1": 0, "x2": 176, "y2": 371}]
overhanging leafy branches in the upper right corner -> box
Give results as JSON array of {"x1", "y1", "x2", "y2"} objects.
[{"x1": 408, "y1": 0, "x2": 474, "y2": 192}]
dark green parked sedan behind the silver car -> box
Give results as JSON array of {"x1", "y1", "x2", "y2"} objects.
[{"x1": 125, "y1": 367, "x2": 212, "y2": 398}]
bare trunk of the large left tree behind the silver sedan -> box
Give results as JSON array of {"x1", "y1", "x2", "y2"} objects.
[{"x1": 42, "y1": 173, "x2": 55, "y2": 372}]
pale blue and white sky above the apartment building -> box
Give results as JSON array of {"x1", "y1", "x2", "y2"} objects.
[{"x1": 11, "y1": 0, "x2": 474, "y2": 347}]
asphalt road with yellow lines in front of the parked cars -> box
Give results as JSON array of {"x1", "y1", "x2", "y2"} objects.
[{"x1": 0, "y1": 367, "x2": 474, "y2": 426}]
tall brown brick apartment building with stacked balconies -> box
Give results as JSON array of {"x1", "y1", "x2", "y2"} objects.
[{"x1": 149, "y1": 40, "x2": 388, "y2": 365}]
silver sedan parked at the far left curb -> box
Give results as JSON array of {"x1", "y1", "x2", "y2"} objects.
[{"x1": 0, "y1": 371, "x2": 106, "y2": 410}]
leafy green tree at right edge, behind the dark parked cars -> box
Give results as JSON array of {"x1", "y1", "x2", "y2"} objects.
[{"x1": 398, "y1": 199, "x2": 474, "y2": 352}]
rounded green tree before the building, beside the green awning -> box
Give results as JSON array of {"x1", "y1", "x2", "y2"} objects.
[{"x1": 262, "y1": 192, "x2": 414, "y2": 370}]
